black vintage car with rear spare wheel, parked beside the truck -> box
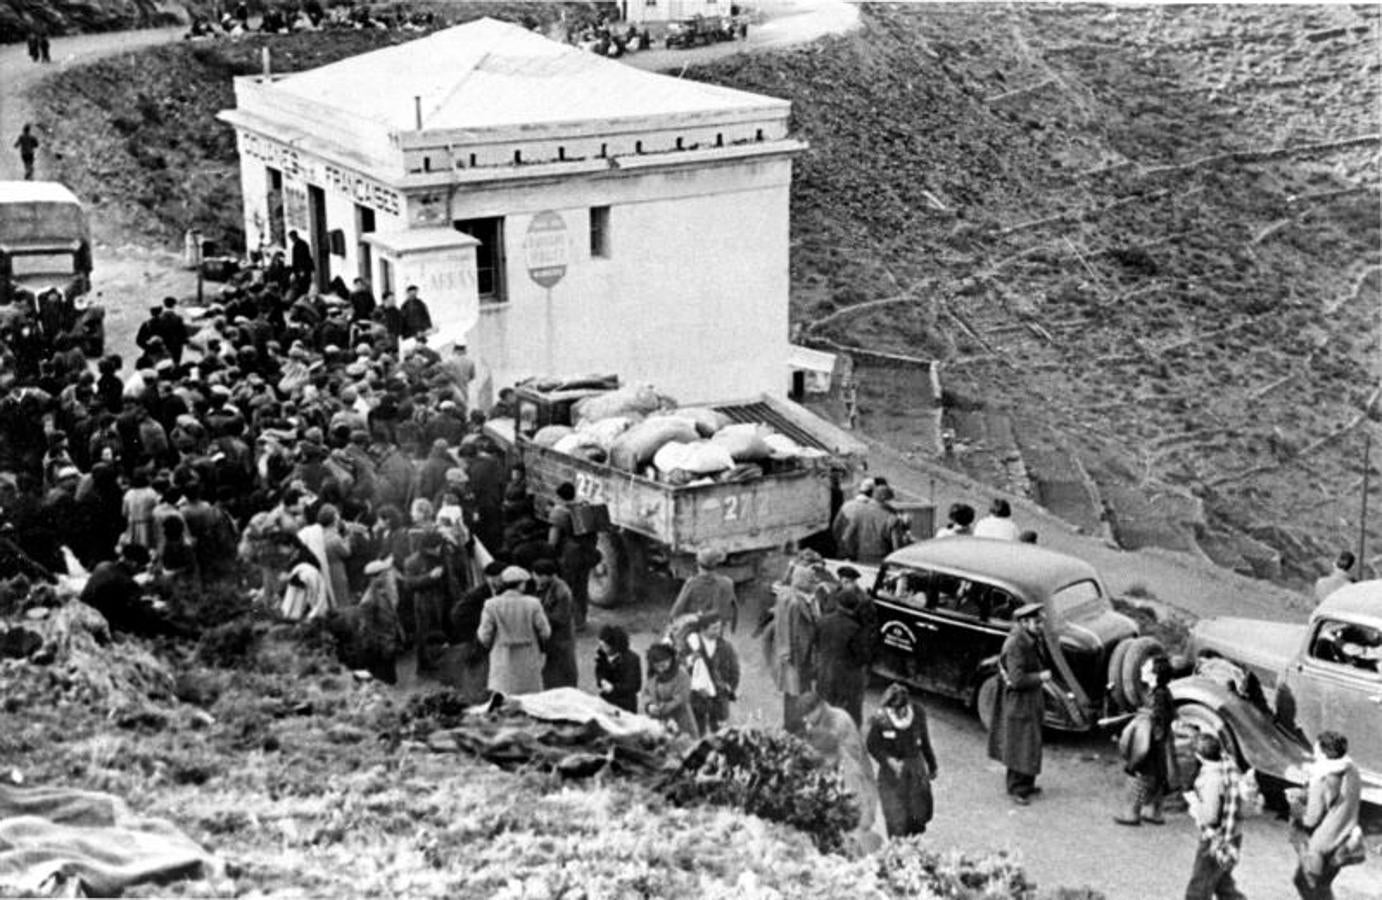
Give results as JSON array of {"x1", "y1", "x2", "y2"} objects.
[{"x1": 865, "y1": 538, "x2": 1144, "y2": 731}]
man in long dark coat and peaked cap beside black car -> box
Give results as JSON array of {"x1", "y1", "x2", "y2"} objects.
[{"x1": 988, "y1": 603, "x2": 1052, "y2": 806}]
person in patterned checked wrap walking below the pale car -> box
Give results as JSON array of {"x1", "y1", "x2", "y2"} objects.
[{"x1": 1186, "y1": 734, "x2": 1247, "y2": 900}]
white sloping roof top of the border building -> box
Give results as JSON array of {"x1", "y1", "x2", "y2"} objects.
[{"x1": 272, "y1": 18, "x2": 791, "y2": 131}]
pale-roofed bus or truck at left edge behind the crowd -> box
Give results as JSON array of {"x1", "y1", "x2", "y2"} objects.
[{"x1": 0, "y1": 181, "x2": 104, "y2": 355}]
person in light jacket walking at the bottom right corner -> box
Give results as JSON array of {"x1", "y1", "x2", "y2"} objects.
[{"x1": 1291, "y1": 731, "x2": 1361, "y2": 900}]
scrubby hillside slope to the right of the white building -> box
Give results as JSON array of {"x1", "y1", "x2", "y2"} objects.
[{"x1": 695, "y1": 4, "x2": 1382, "y2": 579}]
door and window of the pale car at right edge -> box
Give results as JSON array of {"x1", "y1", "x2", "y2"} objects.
[{"x1": 1287, "y1": 617, "x2": 1382, "y2": 780}]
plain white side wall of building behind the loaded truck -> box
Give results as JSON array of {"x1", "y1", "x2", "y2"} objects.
[{"x1": 453, "y1": 159, "x2": 791, "y2": 401}]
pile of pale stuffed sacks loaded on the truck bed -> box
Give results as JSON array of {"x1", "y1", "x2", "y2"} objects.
[{"x1": 532, "y1": 384, "x2": 828, "y2": 485}]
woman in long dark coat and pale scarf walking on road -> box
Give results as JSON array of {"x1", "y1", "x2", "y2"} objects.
[{"x1": 864, "y1": 684, "x2": 936, "y2": 838}]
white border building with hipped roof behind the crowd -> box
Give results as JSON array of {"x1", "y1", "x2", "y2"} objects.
[{"x1": 220, "y1": 19, "x2": 806, "y2": 401}]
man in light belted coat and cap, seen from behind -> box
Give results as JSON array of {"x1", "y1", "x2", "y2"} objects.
[{"x1": 477, "y1": 565, "x2": 551, "y2": 694}]
